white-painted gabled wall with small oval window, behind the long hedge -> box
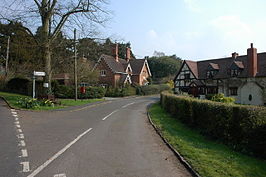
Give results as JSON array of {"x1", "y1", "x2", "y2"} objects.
[{"x1": 239, "y1": 82, "x2": 264, "y2": 105}]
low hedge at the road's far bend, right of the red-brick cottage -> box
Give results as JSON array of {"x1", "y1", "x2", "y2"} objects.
[{"x1": 137, "y1": 84, "x2": 171, "y2": 95}]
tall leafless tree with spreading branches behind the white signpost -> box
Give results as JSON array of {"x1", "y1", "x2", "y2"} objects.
[{"x1": 0, "y1": 0, "x2": 108, "y2": 92}]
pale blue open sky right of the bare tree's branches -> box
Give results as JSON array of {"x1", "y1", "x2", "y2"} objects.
[{"x1": 104, "y1": 0, "x2": 266, "y2": 60}]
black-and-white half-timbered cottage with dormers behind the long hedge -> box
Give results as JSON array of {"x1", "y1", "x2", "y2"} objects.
[{"x1": 174, "y1": 44, "x2": 266, "y2": 105}]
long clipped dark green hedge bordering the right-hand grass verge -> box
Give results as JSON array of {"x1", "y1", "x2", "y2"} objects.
[{"x1": 161, "y1": 92, "x2": 266, "y2": 159}]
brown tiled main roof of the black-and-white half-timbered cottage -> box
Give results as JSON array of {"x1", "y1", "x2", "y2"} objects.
[{"x1": 185, "y1": 53, "x2": 266, "y2": 79}]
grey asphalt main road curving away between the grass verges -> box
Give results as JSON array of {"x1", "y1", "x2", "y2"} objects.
[{"x1": 0, "y1": 97, "x2": 190, "y2": 177}]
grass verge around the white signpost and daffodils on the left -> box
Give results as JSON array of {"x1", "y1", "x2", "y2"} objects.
[{"x1": 0, "y1": 92, "x2": 103, "y2": 110}]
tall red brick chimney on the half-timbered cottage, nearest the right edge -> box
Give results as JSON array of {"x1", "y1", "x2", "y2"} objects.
[{"x1": 247, "y1": 43, "x2": 258, "y2": 77}]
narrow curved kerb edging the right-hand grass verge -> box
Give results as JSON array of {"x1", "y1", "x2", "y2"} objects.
[{"x1": 147, "y1": 103, "x2": 201, "y2": 177}]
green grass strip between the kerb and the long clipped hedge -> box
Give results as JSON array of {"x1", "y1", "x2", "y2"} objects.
[{"x1": 149, "y1": 103, "x2": 266, "y2": 177}]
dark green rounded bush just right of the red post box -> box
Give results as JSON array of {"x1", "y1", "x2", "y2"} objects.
[{"x1": 78, "y1": 87, "x2": 106, "y2": 99}]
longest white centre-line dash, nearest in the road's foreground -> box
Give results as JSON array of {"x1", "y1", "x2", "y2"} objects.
[{"x1": 28, "y1": 128, "x2": 92, "y2": 177}]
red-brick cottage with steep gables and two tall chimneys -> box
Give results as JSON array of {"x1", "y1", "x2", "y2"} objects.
[{"x1": 93, "y1": 44, "x2": 151, "y2": 87}]
